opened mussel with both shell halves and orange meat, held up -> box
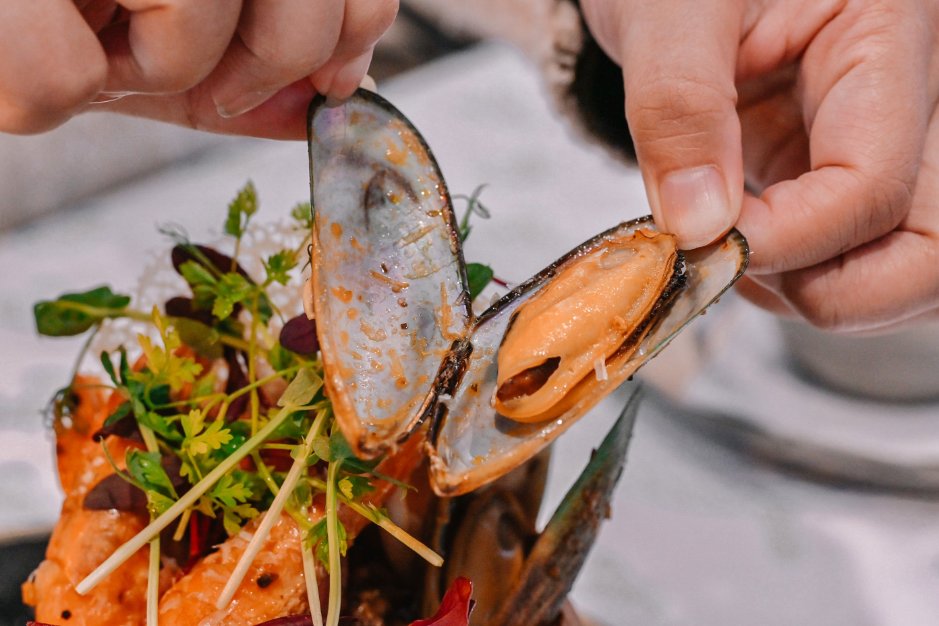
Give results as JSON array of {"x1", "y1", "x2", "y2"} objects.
[{"x1": 310, "y1": 91, "x2": 748, "y2": 495}]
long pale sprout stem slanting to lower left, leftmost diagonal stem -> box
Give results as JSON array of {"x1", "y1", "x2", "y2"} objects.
[{"x1": 75, "y1": 405, "x2": 302, "y2": 595}]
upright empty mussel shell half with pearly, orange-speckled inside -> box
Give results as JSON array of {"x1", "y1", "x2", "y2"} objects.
[{"x1": 309, "y1": 90, "x2": 471, "y2": 457}]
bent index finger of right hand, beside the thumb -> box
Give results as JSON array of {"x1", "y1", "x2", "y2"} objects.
[{"x1": 738, "y1": 3, "x2": 935, "y2": 273}]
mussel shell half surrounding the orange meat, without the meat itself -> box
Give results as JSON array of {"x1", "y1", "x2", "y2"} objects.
[{"x1": 431, "y1": 217, "x2": 748, "y2": 495}]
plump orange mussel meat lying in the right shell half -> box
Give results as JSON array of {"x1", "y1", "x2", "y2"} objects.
[{"x1": 494, "y1": 229, "x2": 684, "y2": 422}]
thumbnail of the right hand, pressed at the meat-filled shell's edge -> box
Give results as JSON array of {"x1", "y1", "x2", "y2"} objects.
[{"x1": 659, "y1": 165, "x2": 734, "y2": 249}]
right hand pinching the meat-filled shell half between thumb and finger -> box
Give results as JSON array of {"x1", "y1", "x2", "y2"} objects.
[{"x1": 582, "y1": 0, "x2": 939, "y2": 331}]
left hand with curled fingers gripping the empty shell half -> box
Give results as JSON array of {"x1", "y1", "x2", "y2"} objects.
[{"x1": 0, "y1": 0, "x2": 398, "y2": 138}]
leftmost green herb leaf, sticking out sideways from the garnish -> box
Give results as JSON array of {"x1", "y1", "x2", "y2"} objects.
[{"x1": 33, "y1": 286, "x2": 130, "y2": 337}]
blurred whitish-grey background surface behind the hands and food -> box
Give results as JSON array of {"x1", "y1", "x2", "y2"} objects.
[{"x1": 0, "y1": 3, "x2": 939, "y2": 626}]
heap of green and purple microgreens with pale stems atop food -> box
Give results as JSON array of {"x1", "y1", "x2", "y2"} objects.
[{"x1": 33, "y1": 182, "x2": 493, "y2": 626}]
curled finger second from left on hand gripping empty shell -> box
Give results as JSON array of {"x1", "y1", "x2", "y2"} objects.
[{"x1": 100, "y1": 0, "x2": 241, "y2": 93}]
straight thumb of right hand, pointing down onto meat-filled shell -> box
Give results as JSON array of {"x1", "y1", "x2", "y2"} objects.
[{"x1": 585, "y1": 0, "x2": 743, "y2": 248}]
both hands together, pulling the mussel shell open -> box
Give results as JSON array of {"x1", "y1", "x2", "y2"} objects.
[{"x1": 0, "y1": 0, "x2": 939, "y2": 331}]
